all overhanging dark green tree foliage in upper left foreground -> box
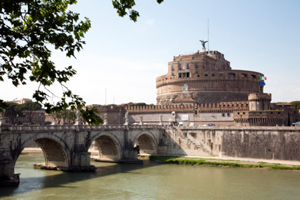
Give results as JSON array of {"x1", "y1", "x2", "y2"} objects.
[{"x1": 0, "y1": 0, "x2": 163, "y2": 125}]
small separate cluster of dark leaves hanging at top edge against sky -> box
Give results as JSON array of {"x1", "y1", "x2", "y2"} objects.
[{"x1": 112, "y1": 0, "x2": 164, "y2": 22}]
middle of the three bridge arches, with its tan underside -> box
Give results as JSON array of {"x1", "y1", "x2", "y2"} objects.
[{"x1": 88, "y1": 133, "x2": 122, "y2": 162}]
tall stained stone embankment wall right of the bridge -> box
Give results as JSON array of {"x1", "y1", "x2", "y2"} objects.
[{"x1": 164, "y1": 127, "x2": 300, "y2": 161}]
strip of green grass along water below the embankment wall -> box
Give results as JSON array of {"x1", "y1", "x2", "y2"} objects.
[{"x1": 149, "y1": 156, "x2": 300, "y2": 170}]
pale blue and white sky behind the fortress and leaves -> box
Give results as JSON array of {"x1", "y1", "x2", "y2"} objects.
[{"x1": 0, "y1": 0, "x2": 300, "y2": 105}]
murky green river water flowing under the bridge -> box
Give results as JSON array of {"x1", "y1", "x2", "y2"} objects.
[{"x1": 0, "y1": 155, "x2": 300, "y2": 200}]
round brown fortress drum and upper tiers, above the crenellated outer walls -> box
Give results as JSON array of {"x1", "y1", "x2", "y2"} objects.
[{"x1": 156, "y1": 51, "x2": 263, "y2": 105}]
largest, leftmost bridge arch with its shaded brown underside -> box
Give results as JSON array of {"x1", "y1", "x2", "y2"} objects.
[{"x1": 20, "y1": 134, "x2": 71, "y2": 169}]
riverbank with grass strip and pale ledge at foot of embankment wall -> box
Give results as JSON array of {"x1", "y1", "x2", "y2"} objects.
[{"x1": 149, "y1": 156, "x2": 300, "y2": 172}]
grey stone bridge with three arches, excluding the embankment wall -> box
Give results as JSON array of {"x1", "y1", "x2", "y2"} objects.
[{"x1": 0, "y1": 125, "x2": 165, "y2": 185}]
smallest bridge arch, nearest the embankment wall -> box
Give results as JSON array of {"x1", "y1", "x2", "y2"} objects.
[{"x1": 133, "y1": 131, "x2": 158, "y2": 154}]
